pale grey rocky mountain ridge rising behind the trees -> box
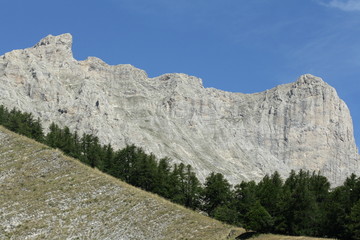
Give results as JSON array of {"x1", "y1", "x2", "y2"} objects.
[{"x1": 0, "y1": 34, "x2": 360, "y2": 185}]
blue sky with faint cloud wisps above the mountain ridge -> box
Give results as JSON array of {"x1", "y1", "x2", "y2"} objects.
[{"x1": 0, "y1": 0, "x2": 360, "y2": 147}]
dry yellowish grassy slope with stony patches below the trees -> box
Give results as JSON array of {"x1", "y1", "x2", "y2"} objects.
[{"x1": 0, "y1": 126, "x2": 332, "y2": 240}]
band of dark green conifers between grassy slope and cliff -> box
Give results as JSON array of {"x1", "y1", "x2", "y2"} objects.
[{"x1": 0, "y1": 106, "x2": 360, "y2": 239}]
